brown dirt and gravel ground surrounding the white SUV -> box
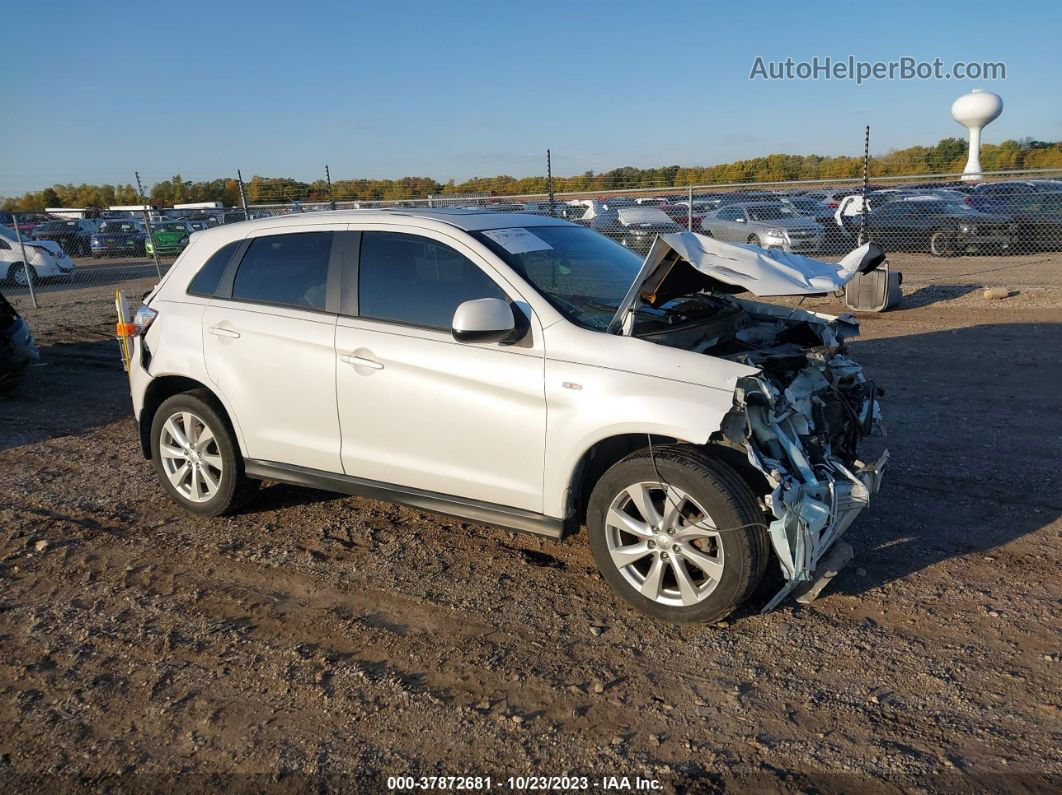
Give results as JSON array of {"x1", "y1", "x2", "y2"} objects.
[{"x1": 0, "y1": 256, "x2": 1062, "y2": 792}]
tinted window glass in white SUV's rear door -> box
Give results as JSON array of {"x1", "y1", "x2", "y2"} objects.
[{"x1": 233, "y1": 231, "x2": 332, "y2": 310}]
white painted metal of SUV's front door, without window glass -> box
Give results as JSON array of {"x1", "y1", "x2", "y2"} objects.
[{"x1": 336, "y1": 223, "x2": 552, "y2": 513}]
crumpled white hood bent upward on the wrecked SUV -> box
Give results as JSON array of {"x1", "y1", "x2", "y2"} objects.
[{"x1": 609, "y1": 231, "x2": 885, "y2": 333}]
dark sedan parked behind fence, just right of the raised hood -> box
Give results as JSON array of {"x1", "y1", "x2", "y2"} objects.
[{"x1": 867, "y1": 198, "x2": 1015, "y2": 257}]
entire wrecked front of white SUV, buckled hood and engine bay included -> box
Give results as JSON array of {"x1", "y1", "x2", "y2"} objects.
[{"x1": 610, "y1": 232, "x2": 888, "y2": 612}]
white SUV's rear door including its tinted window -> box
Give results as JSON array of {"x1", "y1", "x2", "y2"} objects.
[{"x1": 203, "y1": 224, "x2": 345, "y2": 472}]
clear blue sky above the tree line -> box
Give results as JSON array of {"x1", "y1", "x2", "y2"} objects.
[{"x1": 0, "y1": 0, "x2": 1062, "y2": 195}]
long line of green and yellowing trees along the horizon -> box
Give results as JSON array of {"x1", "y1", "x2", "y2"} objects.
[{"x1": 0, "y1": 138, "x2": 1062, "y2": 212}]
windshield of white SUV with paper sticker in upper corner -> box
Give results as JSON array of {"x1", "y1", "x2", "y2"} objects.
[{"x1": 472, "y1": 226, "x2": 641, "y2": 330}]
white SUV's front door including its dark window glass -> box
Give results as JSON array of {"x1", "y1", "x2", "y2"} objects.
[{"x1": 336, "y1": 227, "x2": 546, "y2": 513}]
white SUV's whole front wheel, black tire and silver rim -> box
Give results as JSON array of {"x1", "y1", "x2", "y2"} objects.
[{"x1": 586, "y1": 446, "x2": 768, "y2": 624}]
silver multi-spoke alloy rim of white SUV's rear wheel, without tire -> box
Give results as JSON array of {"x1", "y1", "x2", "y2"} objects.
[{"x1": 158, "y1": 411, "x2": 224, "y2": 502}]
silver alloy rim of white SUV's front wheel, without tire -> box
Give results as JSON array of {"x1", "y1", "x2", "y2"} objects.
[{"x1": 605, "y1": 482, "x2": 723, "y2": 607}]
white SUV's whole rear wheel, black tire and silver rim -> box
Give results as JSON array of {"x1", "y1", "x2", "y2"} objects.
[{"x1": 151, "y1": 390, "x2": 258, "y2": 516}]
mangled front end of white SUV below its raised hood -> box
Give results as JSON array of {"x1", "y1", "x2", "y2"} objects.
[{"x1": 712, "y1": 298, "x2": 889, "y2": 612}]
